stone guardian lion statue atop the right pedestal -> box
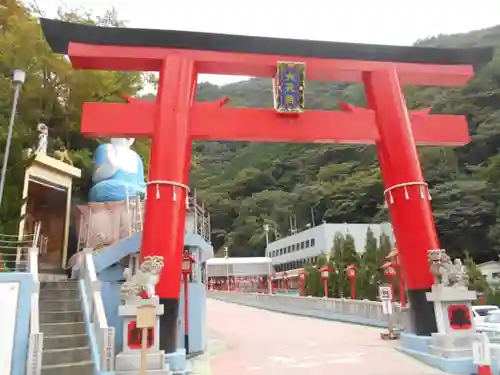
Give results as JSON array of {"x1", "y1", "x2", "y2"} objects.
[{"x1": 428, "y1": 249, "x2": 469, "y2": 287}]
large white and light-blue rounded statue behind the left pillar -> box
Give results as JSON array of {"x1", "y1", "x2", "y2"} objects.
[{"x1": 89, "y1": 138, "x2": 146, "y2": 202}]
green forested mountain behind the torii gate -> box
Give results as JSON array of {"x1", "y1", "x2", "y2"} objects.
[{"x1": 192, "y1": 26, "x2": 500, "y2": 261}]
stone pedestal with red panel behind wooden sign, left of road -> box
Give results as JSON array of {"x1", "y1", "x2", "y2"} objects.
[{"x1": 115, "y1": 300, "x2": 171, "y2": 375}]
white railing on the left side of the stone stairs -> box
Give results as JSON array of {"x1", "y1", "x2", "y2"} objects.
[{"x1": 26, "y1": 247, "x2": 43, "y2": 375}]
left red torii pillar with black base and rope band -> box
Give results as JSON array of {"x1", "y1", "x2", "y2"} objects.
[{"x1": 141, "y1": 55, "x2": 197, "y2": 352}]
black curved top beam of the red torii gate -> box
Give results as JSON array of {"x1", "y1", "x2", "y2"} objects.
[{"x1": 41, "y1": 18, "x2": 493, "y2": 70}]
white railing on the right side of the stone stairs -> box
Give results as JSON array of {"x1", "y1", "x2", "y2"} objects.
[{"x1": 80, "y1": 248, "x2": 115, "y2": 372}]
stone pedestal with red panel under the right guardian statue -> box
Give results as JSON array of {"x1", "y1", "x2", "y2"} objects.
[{"x1": 426, "y1": 284, "x2": 479, "y2": 358}]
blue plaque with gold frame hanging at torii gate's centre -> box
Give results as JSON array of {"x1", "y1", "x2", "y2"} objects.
[{"x1": 274, "y1": 62, "x2": 306, "y2": 113}]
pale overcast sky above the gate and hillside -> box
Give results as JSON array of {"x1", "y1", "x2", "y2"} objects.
[{"x1": 32, "y1": 0, "x2": 500, "y2": 84}]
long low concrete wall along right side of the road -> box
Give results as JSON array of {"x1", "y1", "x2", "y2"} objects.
[{"x1": 207, "y1": 292, "x2": 407, "y2": 328}]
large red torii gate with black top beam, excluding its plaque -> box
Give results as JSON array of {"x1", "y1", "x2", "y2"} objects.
[{"x1": 42, "y1": 19, "x2": 493, "y2": 352}]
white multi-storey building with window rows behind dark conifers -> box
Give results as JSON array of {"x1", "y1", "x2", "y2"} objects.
[{"x1": 266, "y1": 223, "x2": 394, "y2": 272}]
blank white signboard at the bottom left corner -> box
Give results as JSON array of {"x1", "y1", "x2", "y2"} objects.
[{"x1": 0, "y1": 282, "x2": 19, "y2": 374}]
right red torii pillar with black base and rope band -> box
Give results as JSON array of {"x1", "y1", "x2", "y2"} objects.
[{"x1": 363, "y1": 68, "x2": 440, "y2": 334}]
